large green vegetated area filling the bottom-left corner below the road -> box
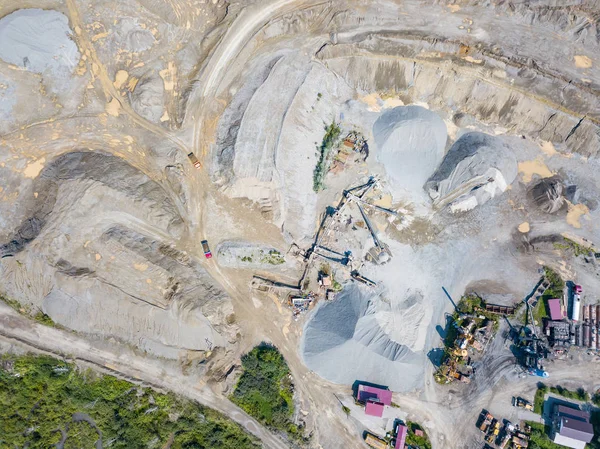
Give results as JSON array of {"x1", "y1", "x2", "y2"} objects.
[{"x1": 0, "y1": 355, "x2": 260, "y2": 449}]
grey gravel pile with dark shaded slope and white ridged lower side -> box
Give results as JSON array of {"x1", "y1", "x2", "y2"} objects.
[{"x1": 425, "y1": 132, "x2": 517, "y2": 212}]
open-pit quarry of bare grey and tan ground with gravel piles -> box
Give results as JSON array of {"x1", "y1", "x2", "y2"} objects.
[{"x1": 0, "y1": 0, "x2": 600, "y2": 449}]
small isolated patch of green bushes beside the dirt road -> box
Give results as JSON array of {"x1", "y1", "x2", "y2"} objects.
[{"x1": 230, "y1": 344, "x2": 300, "y2": 440}]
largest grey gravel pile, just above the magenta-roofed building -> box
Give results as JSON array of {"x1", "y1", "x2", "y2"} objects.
[{"x1": 301, "y1": 285, "x2": 424, "y2": 391}]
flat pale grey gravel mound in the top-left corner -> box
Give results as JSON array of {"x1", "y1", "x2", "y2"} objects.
[{"x1": 0, "y1": 9, "x2": 79, "y2": 90}]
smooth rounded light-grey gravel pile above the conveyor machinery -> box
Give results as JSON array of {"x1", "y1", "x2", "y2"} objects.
[{"x1": 373, "y1": 106, "x2": 447, "y2": 196}]
